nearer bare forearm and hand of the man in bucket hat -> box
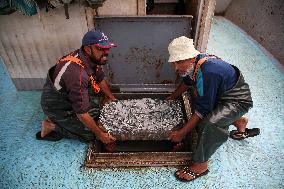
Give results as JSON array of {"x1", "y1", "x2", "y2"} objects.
[{"x1": 169, "y1": 113, "x2": 201, "y2": 142}]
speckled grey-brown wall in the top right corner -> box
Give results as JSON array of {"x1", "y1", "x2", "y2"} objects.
[{"x1": 225, "y1": 0, "x2": 284, "y2": 64}]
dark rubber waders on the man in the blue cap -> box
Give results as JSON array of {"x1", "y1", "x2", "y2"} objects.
[{"x1": 41, "y1": 68, "x2": 100, "y2": 142}]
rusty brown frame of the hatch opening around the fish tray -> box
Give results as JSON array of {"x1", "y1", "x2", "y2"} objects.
[{"x1": 85, "y1": 91, "x2": 197, "y2": 168}]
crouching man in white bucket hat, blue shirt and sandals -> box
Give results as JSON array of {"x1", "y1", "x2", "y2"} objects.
[{"x1": 167, "y1": 36, "x2": 259, "y2": 181}]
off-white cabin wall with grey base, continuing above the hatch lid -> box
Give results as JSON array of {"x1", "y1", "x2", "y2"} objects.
[{"x1": 0, "y1": 0, "x2": 146, "y2": 90}]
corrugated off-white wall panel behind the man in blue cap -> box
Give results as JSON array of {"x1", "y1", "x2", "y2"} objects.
[{"x1": 0, "y1": 4, "x2": 87, "y2": 78}]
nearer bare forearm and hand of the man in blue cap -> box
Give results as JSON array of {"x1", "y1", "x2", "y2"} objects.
[{"x1": 77, "y1": 113, "x2": 115, "y2": 144}]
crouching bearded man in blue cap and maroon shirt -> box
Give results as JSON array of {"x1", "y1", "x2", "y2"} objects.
[{"x1": 36, "y1": 30, "x2": 116, "y2": 144}]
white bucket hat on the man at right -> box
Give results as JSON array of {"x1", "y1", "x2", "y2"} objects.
[{"x1": 168, "y1": 36, "x2": 200, "y2": 62}]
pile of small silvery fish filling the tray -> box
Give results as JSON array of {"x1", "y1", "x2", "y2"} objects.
[{"x1": 100, "y1": 98, "x2": 183, "y2": 140}]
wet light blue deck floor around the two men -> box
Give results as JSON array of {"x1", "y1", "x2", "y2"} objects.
[{"x1": 0, "y1": 17, "x2": 284, "y2": 189}]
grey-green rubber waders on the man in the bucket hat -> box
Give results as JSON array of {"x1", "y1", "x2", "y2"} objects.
[{"x1": 192, "y1": 66, "x2": 253, "y2": 163}]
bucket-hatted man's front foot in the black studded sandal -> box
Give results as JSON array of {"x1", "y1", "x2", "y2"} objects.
[{"x1": 176, "y1": 161, "x2": 208, "y2": 181}]
